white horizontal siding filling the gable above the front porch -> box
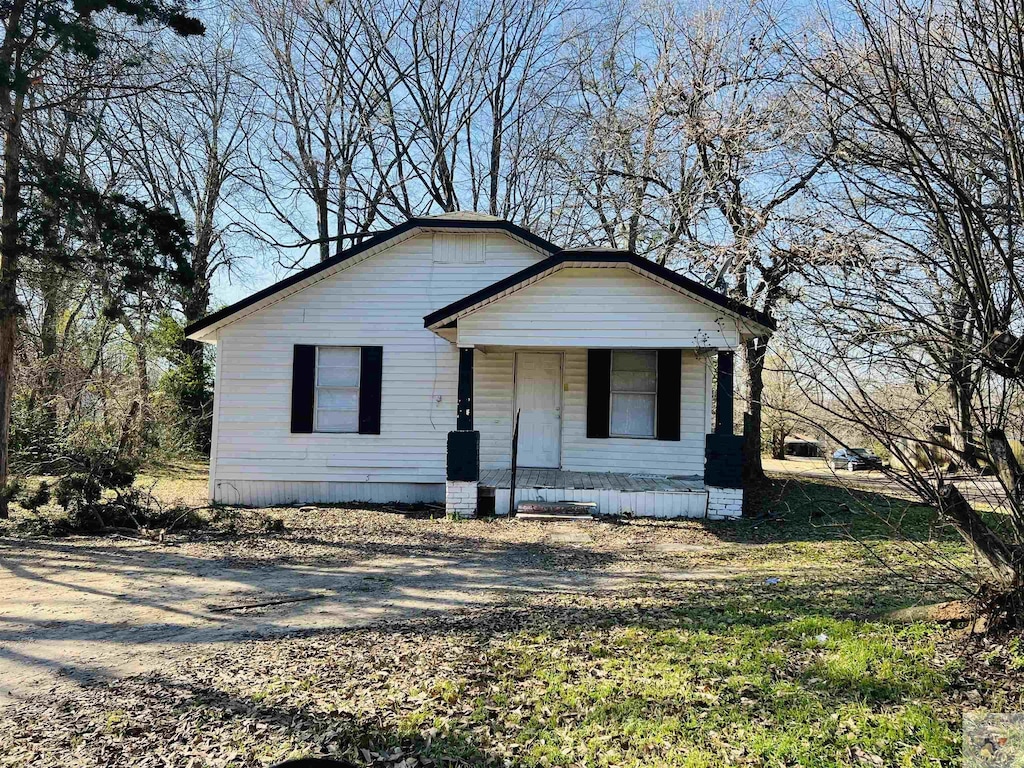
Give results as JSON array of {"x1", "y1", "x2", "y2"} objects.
[{"x1": 459, "y1": 267, "x2": 739, "y2": 348}]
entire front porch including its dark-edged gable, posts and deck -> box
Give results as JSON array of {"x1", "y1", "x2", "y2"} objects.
[{"x1": 424, "y1": 252, "x2": 760, "y2": 517}]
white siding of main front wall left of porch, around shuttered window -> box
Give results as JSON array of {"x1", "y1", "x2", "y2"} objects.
[{"x1": 211, "y1": 233, "x2": 543, "y2": 504}]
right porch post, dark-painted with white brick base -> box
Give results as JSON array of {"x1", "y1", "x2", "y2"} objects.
[{"x1": 705, "y1": 350, "x2": 743, "y2": 519}]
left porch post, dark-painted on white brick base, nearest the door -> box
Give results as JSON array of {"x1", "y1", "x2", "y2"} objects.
[{"x1": 444, "y1": 347, "x2": 480, "y2": 517}]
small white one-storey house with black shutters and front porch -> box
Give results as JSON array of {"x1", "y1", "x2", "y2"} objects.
[{"x1": 186, "y1": 213, "x2": 774, "y2": 517}]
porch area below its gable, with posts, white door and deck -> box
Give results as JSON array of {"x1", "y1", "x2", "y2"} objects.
[{"x1": 446, "y1": 345, "x2": 741, "y2": 518}]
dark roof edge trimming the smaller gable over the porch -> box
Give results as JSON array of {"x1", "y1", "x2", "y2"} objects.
[{"x1": 423, "y1": 248, "x2": 775, "y2": 331}]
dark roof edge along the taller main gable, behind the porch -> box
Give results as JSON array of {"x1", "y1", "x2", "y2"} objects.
[{"x1": 184, "y1": 211, "x2": 558, "y2": 337}]
